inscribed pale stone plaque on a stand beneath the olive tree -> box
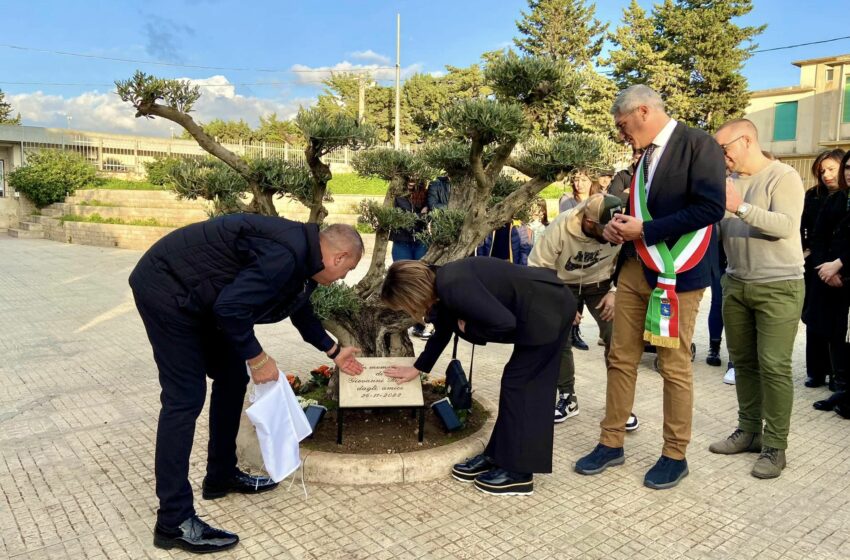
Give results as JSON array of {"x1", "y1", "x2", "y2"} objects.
[{"x1": 339, "y1": 358, "x2": 425, "y2": 408}]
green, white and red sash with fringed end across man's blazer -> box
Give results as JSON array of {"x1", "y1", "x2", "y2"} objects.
[{"x1": 629, "y1": 161, "x2": 712, "y2": 348}]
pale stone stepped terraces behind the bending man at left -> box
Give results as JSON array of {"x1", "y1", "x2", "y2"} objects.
[{"x1": 8, "y1": 189, "x2": 383, "y2": 250}]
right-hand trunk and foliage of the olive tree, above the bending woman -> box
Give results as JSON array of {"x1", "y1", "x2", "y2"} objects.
[{"x1": 421, "y1": 52, "x2": 606, "y2": 264}]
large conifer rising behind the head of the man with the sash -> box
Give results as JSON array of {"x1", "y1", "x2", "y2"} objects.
[{"x1": 607, "y1": 0, "x2": 765, "y2": 131}]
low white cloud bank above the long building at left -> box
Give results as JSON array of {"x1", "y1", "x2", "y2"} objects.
[{"x1": 6, "y1": 76, "x2": 314, "y2": 136}]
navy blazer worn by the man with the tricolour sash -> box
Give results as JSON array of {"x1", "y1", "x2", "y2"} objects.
[{"x1": 618, "y1": 123, "x2": 726, "y2": 292}]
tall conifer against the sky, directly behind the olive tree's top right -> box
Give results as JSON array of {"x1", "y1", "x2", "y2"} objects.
[{"x1": 514, "y1": 0, "x2": 616, "y2": 136}]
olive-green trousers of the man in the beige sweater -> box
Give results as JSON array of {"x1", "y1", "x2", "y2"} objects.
[{"x1": 721, "y1": 275, "x2": 805, "y2": 449}]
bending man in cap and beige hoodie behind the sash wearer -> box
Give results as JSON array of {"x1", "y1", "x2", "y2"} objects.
[{"x1": 528, "y1": 194, "x2": 638, "y2": 431}]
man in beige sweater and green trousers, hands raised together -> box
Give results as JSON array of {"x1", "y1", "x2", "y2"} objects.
[{"x1": 709, "y1": 119, "x2": 804, "y2": 478}]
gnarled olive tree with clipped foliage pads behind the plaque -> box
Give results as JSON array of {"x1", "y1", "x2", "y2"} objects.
[{"x1": 117, "y1": 52, "x2": 607, "y2": 372}]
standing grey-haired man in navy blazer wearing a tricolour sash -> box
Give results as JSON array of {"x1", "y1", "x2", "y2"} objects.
[{"x1": 575, "y1": 85, "x2": 726, "y2": 490}]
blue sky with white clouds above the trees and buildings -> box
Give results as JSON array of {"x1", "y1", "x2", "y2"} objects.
[{"x1": 0, "y1": 0, "x2": 850, "y2": 135}]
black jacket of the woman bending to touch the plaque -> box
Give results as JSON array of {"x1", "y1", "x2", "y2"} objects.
[{"x1": 416, "y1": 257, "x2": 576, "y2": 372}]
